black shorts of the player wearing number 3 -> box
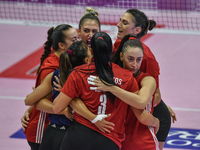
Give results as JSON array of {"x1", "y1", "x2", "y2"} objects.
[{"x1": 60, "y1": 120, "x2": 119, "y2": 150}]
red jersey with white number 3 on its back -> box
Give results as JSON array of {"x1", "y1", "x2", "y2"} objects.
[{"x1": 61, "y1": 62, "x2": 138, "y2": 148}]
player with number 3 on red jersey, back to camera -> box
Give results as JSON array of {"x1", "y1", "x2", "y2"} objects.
[{"x1": 53, "y1": 32, "x2": 142, "y2": 150}]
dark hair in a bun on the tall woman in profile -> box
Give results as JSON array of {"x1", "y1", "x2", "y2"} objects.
[{"x1": 126, "y1": 9, "x2": 156, "y2": 39}]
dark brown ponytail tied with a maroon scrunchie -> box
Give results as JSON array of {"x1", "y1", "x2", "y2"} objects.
[{"x1": 59, "y1": 41, "x2": 88, "y2": 86}]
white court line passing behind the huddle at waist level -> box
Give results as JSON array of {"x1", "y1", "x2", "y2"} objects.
[{"x1": 0, "y1": 96, "x2": 200, "y2": 112}]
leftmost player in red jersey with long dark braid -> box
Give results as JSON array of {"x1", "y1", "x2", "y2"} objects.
[{"x1": 21, "y1": 24, "x2": 78, "y2": 150}]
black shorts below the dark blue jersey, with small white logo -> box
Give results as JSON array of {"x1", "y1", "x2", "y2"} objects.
[{"x1": 39, "y1": 123, "x2": 69, "y2": 150}]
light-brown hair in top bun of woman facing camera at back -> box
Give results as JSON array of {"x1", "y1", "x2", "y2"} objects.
[{"x1": 79, "y1": 7, "x2": 101, "y2": 30}]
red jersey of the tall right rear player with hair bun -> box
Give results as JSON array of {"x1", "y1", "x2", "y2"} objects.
[{"x1": 113, "y1": 39, "x2": 160, "y2": 87}]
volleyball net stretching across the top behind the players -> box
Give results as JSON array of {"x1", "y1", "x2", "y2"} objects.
[{"x1": 0, "y1": 0, "x2": 200, "y2": 31}]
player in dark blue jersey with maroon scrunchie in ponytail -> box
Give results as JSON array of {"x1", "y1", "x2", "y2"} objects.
[{"x1": 25, "y1": 41, "x2": 92, "y2": 150}]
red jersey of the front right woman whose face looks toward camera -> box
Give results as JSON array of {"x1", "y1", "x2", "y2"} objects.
[{"x1": 122, "y1": 73, "x2": 159, "y2": 150}]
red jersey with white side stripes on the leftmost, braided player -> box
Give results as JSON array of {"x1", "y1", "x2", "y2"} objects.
[{"x1": 25, "y1": 54, "x2": 59, "y2": 143}]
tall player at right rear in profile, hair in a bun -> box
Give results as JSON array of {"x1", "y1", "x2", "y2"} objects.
[{"x1": 112, "y1": 9, "x2": 176, "y2": 149}]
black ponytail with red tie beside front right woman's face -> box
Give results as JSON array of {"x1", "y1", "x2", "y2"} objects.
[{"x1": 111, "y1": 34, "x2": 136, "y2": 68}]
